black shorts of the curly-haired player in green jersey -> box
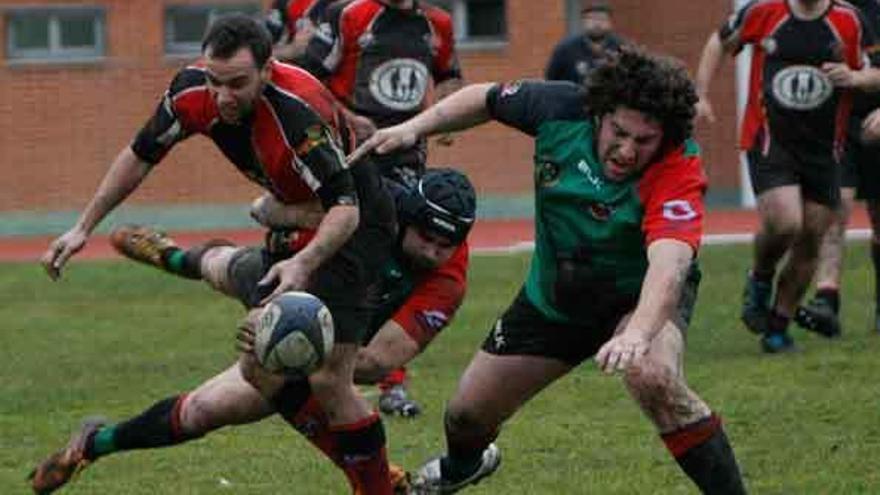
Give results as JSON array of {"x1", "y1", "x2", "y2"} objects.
[{"x1": 482, "y1": 263, "x2": 701, "y2": 366}]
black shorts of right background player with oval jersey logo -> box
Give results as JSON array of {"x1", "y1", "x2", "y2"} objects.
[{"x1": 746, "y1": 134, "x2": 841, "y2": 208}]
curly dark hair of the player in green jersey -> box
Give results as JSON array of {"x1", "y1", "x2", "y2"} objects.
[{"x1": 586, "y1": 46, "x2": 697, "y2": 146}]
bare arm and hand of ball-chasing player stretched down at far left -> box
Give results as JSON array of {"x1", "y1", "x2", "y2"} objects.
[{"x1": 40, "y1": 147, "x2": 150, "y2": 280}]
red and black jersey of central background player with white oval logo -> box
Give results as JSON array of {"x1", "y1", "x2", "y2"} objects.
[{"x1": 304, "y1": 0, "x2": 461, "y2": 128}]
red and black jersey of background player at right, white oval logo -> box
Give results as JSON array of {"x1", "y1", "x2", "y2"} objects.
[{"x1": 719, "y1": 0, "x2": 869, "y2": 156}]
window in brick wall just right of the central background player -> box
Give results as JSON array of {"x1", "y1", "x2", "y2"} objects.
[{"x1": 431, "y1": 0, "x2": 507, "y2": 47}]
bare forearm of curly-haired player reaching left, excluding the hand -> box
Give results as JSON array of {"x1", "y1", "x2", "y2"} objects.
[{"x1": 407, "y1": 83, "x2": 492, "y2": 137}]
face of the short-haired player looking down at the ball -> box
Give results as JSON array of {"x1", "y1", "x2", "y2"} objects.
[{"x1": 205, "y1": 47, "x2": 268, "y2": 124}]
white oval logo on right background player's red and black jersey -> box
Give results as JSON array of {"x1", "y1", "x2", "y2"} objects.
[{"x1": 772, "y1": 65, "x2": 834, "y2": 110}]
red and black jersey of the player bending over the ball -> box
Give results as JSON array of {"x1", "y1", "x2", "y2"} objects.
[{"x1": 131, "y1": 61, "x2": 357, "y2": 208}]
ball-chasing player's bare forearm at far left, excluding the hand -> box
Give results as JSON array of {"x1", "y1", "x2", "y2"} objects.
[{"x1": 77, "y1": 147, "x2": 150, "y2": 233}]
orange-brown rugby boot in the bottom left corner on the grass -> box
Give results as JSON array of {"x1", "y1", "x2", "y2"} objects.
[{"x1": 28, "y1": 418, "x2": 105, "y2": 495}]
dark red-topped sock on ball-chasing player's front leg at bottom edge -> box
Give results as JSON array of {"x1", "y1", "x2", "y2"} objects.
[{"x1": 330, "y1": 412, "x2": 393, "y2": 495}]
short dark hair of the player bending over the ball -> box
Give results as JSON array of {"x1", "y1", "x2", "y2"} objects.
[{"x1": 202, "y1": 14, "x2": 272, "y2": 68}]
